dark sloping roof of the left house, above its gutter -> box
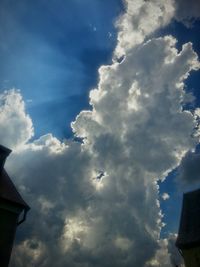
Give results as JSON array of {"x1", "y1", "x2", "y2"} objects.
[{"x1": 0, "y1": 169, "x2": 30, "y2": 210}]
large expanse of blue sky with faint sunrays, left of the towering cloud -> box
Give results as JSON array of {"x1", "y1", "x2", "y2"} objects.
[{"x1": 0, "y1": 0, "x2": 123, "y2": 138}]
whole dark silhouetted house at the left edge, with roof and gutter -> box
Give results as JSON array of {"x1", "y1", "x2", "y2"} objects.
[{"x1": 0, "y1": 145, "x2": 30, "y2": 267}]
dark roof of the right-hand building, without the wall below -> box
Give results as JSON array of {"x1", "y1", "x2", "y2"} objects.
[{"x1": 176, "y1": 189, "x2": 200, "y2": 249}]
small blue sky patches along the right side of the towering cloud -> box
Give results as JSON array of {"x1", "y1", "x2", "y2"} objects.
[{"x1": 160, "y1": 21, "x2": 200, "y2": 235}]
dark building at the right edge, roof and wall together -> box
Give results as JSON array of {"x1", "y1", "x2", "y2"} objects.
[{"x1": 176, "y1": 189, "x2": 200, "y2": 267}]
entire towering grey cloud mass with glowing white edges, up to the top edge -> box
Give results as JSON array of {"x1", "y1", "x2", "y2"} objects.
[{"x1": 1, "y1": 0, "x2": 199, "y2": 267}]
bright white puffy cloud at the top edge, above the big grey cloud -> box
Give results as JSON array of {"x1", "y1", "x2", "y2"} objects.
[{"x1": 115, "y1": 0, "x2": 174, "y2": 57}]
